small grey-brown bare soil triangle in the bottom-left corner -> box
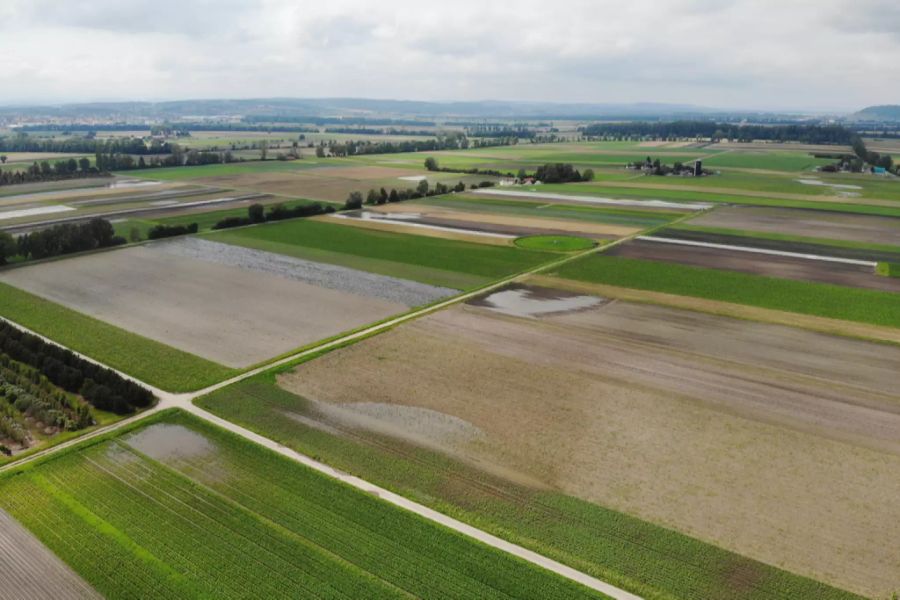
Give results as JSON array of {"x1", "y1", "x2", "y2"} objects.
[{"x1": 0, "y1": 511, "x2": 102, "y2": 600}]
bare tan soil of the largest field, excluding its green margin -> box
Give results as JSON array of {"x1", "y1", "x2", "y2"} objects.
[{"x1": 280, "y1": 294, "x2": 900, "y2": 597}]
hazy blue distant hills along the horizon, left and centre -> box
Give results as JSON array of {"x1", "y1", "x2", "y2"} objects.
[{"x1": 0, "y1": 98, "x2": 721, "y2": 121}]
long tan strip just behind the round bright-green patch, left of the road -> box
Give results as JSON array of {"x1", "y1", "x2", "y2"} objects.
[{"x1": 374, "y1": 202, "x2": 641, "y2": 238}]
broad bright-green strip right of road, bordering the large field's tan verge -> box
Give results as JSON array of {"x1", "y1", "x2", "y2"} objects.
[{"x1": 555, "y1": 255, "x2": 900, "y2": 327}]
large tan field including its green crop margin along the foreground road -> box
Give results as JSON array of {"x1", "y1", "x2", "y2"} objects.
[{"x1": 200, "y1": 293, "x2": 900, "y2": 598}]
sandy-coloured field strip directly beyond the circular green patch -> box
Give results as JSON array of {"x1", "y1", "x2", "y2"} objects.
[{"x1": 372, "y1": 202, "x2": 640, "y2": 239}]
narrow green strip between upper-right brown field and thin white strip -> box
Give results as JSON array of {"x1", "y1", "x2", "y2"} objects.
[{"x1": 654, "y1": 225, "x2": 900, "y2": 262}]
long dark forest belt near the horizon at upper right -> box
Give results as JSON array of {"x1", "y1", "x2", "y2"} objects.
[{"x1": 580, "y1": 121, "x2": 855, "y2": 145}]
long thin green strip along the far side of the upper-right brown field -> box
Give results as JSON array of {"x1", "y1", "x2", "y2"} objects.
[{"x1": 540, "y1": 183, "x2": 900, "y2": 217}]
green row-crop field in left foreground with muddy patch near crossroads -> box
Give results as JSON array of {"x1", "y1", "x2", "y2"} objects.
[{"x1": 0, "y1": 412, "x2": 602, "y2": 600}]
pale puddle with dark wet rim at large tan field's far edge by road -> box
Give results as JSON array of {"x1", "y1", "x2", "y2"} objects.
[{"x1": 469, "y1": 284, "x2": 609, "y2": 317}]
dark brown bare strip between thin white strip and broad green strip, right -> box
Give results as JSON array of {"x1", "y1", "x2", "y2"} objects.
[{"x1": 608, "y1": 240, "x2": 900, "y2": 292}]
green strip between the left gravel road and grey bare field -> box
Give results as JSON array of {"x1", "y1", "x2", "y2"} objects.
[{"x1": 0, "y1": 283, "x2": 238, "y2": 392}]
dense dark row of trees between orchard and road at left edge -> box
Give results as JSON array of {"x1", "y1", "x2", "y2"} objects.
[{"x1": 0, "y1": 321, "x2": 153, "y2": 415}]
